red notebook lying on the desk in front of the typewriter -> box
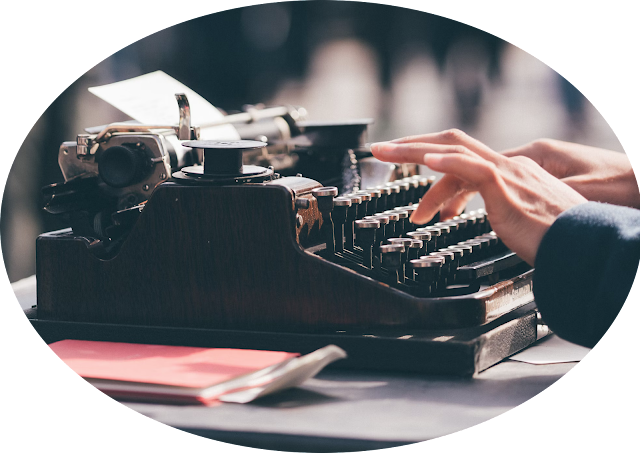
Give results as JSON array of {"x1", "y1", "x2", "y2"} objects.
[{"x1": 49, "y1": 340, "x2": 300, "y2": 404}]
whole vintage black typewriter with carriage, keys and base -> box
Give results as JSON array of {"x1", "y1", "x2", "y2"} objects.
[{"x1": 27, "y1": 94, "x2": 548, "y2": 375}]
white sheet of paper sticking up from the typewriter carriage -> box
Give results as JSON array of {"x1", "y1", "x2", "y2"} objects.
[{"x1": 89, "y1": 71, "x2": 240, "y2": 140}]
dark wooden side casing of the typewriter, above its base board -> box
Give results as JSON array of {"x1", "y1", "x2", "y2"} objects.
[{"x1": 37, "y1": 177, "x2": 531, "y2": 332}]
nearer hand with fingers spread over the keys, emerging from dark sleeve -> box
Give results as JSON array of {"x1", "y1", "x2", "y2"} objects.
[{"x1": 371, "y1": 130, "x2": 588, "y2": 265}]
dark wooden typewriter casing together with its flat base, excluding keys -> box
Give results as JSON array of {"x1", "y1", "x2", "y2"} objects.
[{"x1": 30, "y1": 138, "x2": 540, "y2": 374}]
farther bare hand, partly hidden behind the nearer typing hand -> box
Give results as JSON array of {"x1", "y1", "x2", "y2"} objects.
[{"x1": 501, "y1": 139, "x2": 640, "y2": 208}]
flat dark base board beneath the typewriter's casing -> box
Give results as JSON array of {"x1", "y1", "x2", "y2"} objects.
[{"x1": 26, "y1": 302, "x2": 548, "y2": 377}]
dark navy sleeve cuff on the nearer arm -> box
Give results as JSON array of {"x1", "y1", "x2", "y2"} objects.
[{"x1": 533, "y1": 202, "x2": 640, "y2": 348}]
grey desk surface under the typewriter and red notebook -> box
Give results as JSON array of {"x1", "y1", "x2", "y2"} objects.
[{"x1": 12, "y1": 279, "x2": 588, "y2": 451}]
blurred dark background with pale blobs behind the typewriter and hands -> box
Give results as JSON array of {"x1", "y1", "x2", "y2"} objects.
[{"x1": 0, "y1": 2, "x2": 624, "y2": 282}]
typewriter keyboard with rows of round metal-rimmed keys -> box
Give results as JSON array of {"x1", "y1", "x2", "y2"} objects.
[{"x1": 309, "y1": 176, "x2": 530, "y2": 297}]
